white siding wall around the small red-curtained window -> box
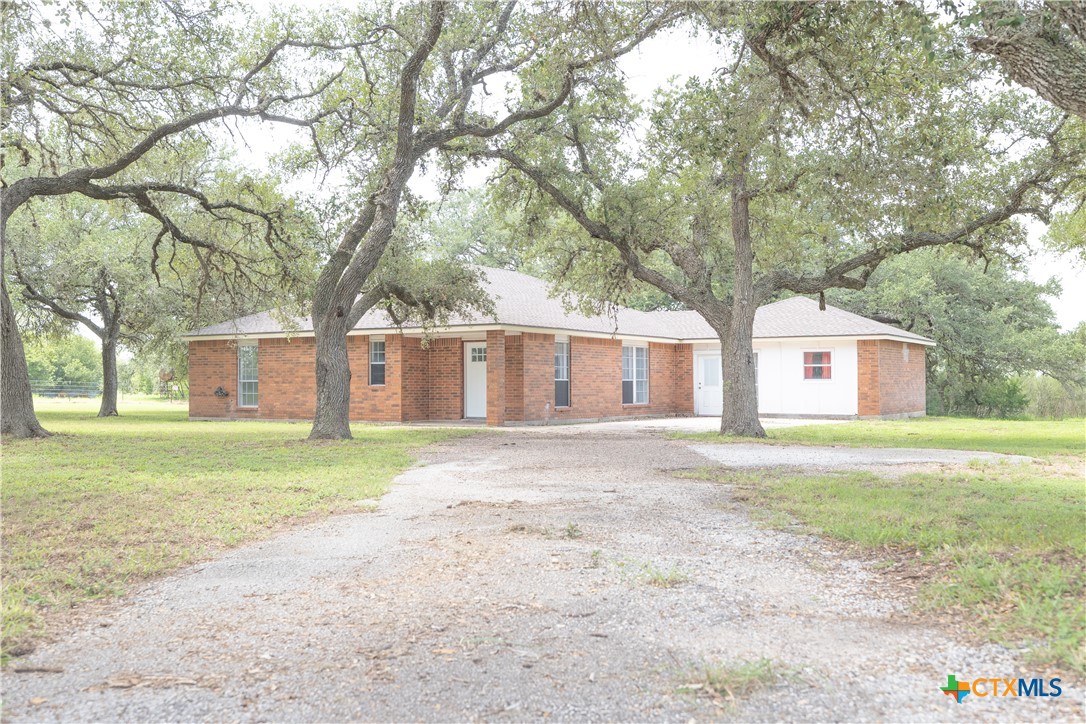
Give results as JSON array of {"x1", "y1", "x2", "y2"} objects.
[{"x1": 694, "y1": 339, "x2": 859, "y2": 415}]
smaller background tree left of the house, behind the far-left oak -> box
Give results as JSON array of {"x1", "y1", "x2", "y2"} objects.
[{"x1": 8, "y1": 158, "x2": 312, "y2": 417}]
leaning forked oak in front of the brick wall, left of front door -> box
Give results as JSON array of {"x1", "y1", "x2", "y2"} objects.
[{"x1": 293, "y1": 1, "x2": 680, "y2": 439}]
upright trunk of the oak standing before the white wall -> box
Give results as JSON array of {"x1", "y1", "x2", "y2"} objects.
[{"x1": 717, "y1": 160, "x2": 766, "y2": 437}]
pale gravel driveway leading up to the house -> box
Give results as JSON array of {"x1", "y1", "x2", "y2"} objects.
[{"x1": 3, "y1": 430, "x2": 1084, "y2": 722}]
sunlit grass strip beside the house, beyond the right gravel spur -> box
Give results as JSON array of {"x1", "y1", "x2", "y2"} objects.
[{"x1": 674, "y1": 417, "x2": 1086, "y2": 457}]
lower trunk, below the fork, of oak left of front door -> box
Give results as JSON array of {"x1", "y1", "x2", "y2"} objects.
[{"x1": 310, "y1": 318, "x2": 351, "y2": 440}]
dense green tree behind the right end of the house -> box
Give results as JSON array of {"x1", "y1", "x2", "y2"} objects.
[{"x1": 832, "y1": 250, "x2": 1086, "y2": 417}]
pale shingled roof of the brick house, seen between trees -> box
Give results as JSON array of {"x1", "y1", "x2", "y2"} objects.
[{"x1": 186, "y1": 268, "x2": 934, "y2": 345}]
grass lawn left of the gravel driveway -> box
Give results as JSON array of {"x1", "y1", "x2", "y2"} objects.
[{"x1": 2, "y1": 401, "x2": 472, "y2": 655}]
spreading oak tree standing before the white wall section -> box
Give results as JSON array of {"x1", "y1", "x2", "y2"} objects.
[{"x1": 480, "y1": 3, "x2": 1086, "y2": 436}]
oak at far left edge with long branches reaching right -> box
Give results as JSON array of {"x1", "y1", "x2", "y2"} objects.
[{"x1": 0, "y1": 0, "x2": 339, "y2": 436}]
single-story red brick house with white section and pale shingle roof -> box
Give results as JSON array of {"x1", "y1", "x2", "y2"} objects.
[{"x1": 187, "y1": 269, "x2": 935, "y2": 425}]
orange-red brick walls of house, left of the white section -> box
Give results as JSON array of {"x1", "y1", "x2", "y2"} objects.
[{"x1": 189, "y1": 330, "x2": 695, "y2": 424}]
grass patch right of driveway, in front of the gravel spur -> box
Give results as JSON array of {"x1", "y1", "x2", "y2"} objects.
[{"x1": 695, "y1": 458, "x2": 1086, "y2": 675}]
